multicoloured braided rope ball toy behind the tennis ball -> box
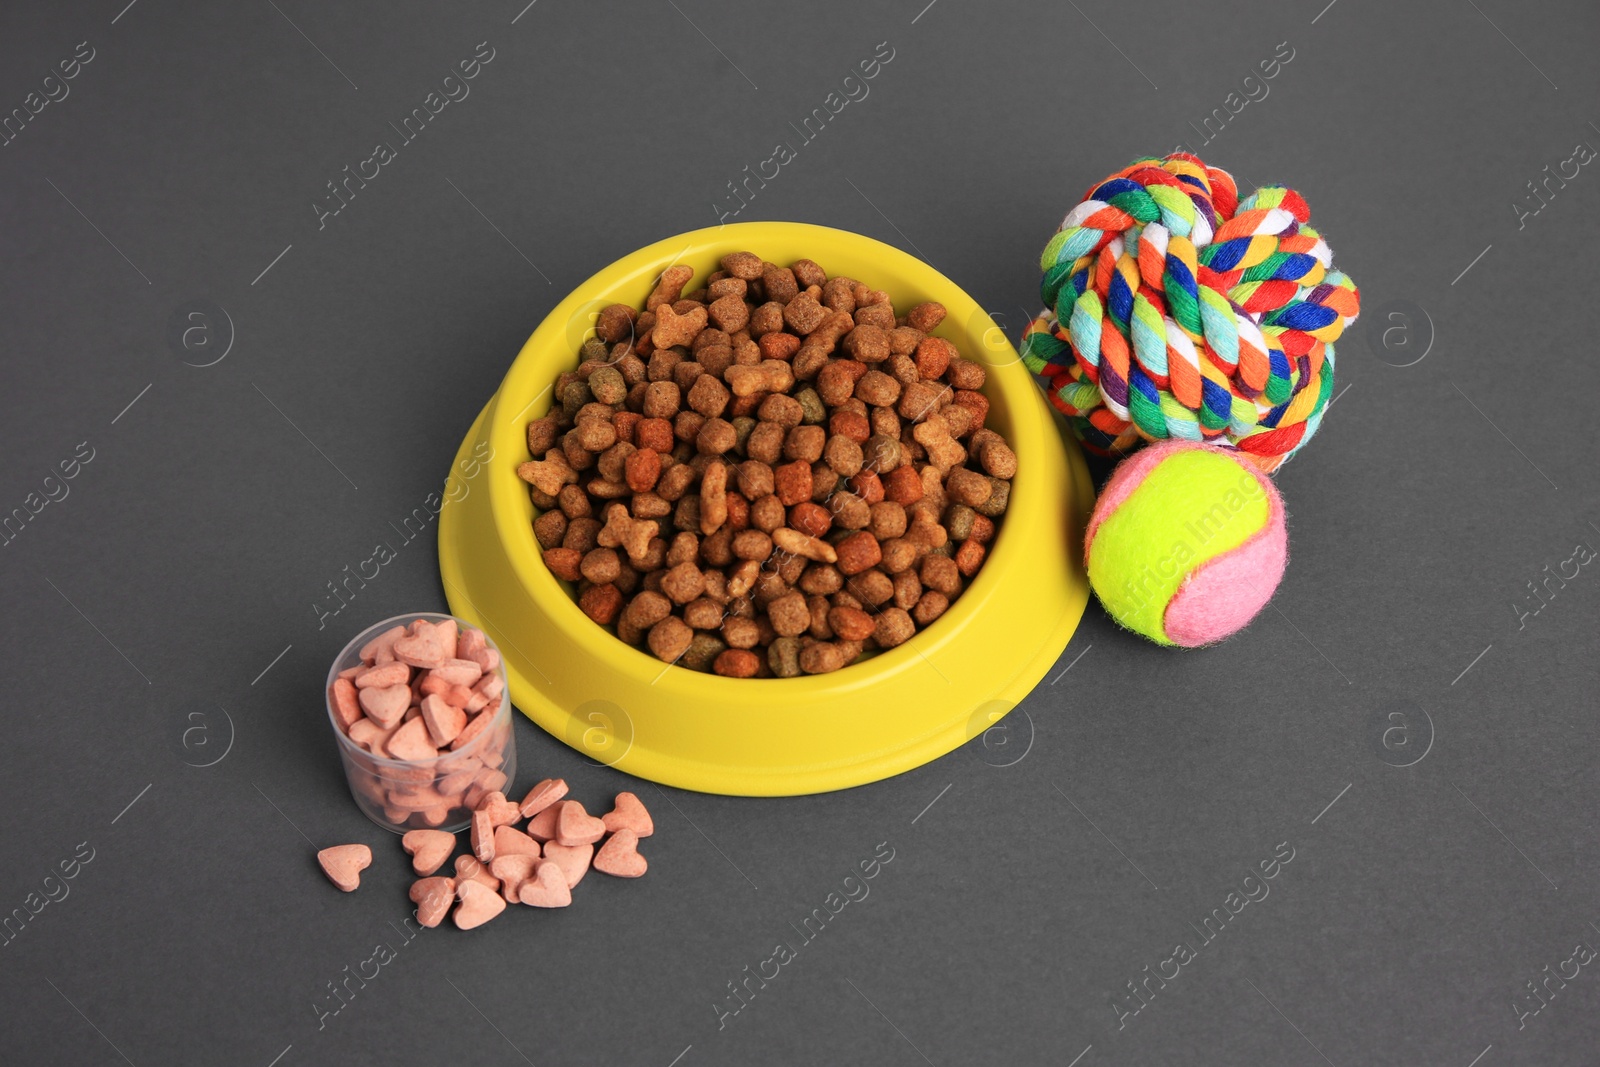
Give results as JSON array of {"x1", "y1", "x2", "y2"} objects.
[{"x1": 1022, "y1": 152, "x2": 1360, "y2": 470}]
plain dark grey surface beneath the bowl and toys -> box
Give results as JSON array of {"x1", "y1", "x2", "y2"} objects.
[{"x1": 0, "y1": 0, "x2": 1600, "y2": 1067}]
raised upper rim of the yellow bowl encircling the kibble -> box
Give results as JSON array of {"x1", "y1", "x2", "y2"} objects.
[{"x1": 486, "y1": 221, "x2": 1059, "y2": 701}]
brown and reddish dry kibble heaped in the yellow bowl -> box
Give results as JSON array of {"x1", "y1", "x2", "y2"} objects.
[{"x1": 517, "y1": 251, "x2": 1018, "y2": 675}]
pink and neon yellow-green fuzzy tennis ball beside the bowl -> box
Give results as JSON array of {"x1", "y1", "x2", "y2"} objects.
[{"x1": 1083, "y1": 442, "x2": 1288, "y2": 648}]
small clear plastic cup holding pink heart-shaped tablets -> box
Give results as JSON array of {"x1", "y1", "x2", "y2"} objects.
[{"x1": 325, "y1": 611, "x2": 517, "y2": 833}]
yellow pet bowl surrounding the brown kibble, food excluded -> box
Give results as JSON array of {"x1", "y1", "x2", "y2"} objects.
[{"x1": 438, "y1": 222, "x2": 1094, "y2": 797}]
